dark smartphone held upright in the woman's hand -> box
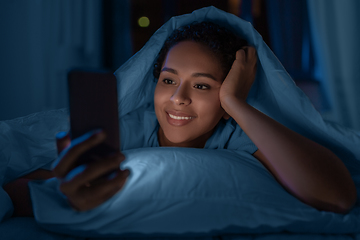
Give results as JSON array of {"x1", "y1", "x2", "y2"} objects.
[{"x1": 68, "y1": 70, "x2": 120, "y2": 165}]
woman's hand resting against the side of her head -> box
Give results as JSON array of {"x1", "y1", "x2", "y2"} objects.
[{"x1": 219, "y1": 47, "x2": 257, "y2": 109}]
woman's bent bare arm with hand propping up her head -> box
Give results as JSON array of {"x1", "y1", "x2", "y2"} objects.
[{"x1": 220, "y1": 47, "x2": 356, "y2": 213}]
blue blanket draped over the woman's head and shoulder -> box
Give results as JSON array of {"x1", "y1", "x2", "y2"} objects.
[{"x1": 115, "y1": 7, "x2": 360, "y2": 181}]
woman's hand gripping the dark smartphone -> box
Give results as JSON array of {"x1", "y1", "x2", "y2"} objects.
[{"x1": 53, "y1": 132, "x2": 130, "y2": 211}]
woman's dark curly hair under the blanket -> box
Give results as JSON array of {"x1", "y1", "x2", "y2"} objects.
[{"x1": 153, "y1": 22, "x2": 247, "y2": 79}]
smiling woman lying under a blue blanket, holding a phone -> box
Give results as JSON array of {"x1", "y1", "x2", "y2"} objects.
[{"x1": 3, "y1": 22, "x2": 356, "y2": 215}]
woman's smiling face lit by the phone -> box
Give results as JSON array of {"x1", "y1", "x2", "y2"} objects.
[{"x1": 154, "y1": 41, "x2": 226, "y2": 148}]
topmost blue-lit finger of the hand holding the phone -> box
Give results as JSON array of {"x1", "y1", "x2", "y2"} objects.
[{"x1": 53, "y1": 131, "x2": 106, "y2": 178}]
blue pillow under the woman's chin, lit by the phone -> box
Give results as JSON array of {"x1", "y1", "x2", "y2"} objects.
[{"x1": 30, "y1": 148, "x2": 360, "y2": 237}]
